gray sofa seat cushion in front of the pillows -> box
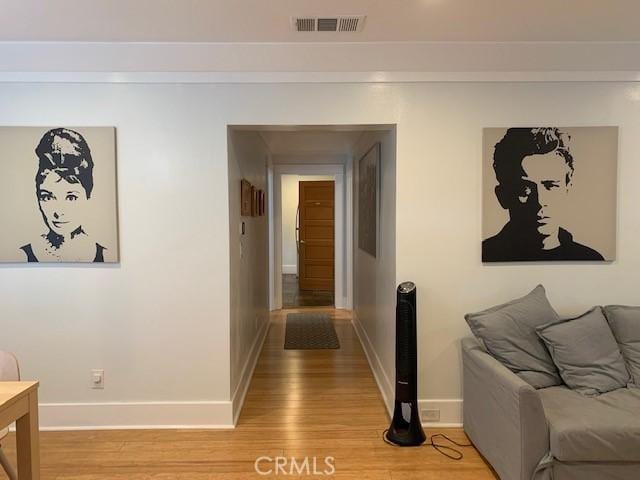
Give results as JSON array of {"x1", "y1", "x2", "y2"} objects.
[{"x1": 538, "y1": 386, "x2": 640, "y2": 462}]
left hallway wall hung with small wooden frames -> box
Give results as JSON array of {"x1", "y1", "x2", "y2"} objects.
[{"x1": 229, "y1": 129, "x2": 269, "y2": 418}]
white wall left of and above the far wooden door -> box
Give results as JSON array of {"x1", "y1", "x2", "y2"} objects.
[{"x1": 281, "y1": 175, "x2": 333, "y2": 274}]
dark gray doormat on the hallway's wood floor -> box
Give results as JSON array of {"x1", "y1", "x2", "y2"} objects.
[{"x1": 284, "y1": 313, "x2": 340, "y2": 350}]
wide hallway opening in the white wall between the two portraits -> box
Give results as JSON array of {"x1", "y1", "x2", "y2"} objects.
[{"x1": 229, "y1": 125, "x2": 396, "y2": 428}]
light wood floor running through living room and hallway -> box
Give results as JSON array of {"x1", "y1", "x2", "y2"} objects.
[{"x1": 0, "y1": 309, "x2": 497, "y2": 480}]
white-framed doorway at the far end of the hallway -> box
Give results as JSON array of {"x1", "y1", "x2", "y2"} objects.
[{"x1": 270, "y1": 160, "x2": 351, "y2": 310}]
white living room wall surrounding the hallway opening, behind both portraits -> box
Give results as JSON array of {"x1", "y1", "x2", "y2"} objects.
[{"x1": 0, "y1": 82, "x2": 640, "y2": 423}]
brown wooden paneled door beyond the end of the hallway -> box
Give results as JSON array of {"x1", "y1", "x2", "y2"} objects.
[{"x1": 298, "y1": 181, "x2": 335, "y2": 291}]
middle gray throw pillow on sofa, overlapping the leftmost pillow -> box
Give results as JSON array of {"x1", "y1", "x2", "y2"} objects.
[{"x1": 536, "y1": 307, "x2": 630, "y2": 395}]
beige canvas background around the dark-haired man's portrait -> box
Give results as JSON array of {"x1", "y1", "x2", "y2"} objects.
[{"x1": 482, "y1": 127, "x2": 618, "y2": 261}]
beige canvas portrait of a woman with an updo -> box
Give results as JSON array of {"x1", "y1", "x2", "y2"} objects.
[{"x1": 0, "y1": 127, "x2": 118, "y2": 263}]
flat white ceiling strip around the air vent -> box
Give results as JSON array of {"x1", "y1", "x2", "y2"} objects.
[{"x1": 0, "y1": 0, "x2": 640, "y2": 42}]
